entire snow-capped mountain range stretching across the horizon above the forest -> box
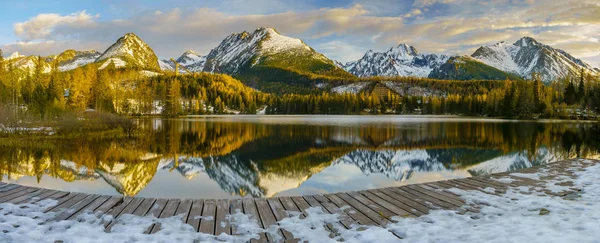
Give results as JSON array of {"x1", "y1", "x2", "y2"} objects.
[{"x1": 6, "y1": 27, "x2": 600, "y2": 83}]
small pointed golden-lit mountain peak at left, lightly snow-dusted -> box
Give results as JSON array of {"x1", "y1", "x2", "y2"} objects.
[{"x1": 96, "y1": 33, "x2": 160, "y2": 70}]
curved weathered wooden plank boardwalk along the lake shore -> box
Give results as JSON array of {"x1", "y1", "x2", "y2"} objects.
[{"x1": 0, "y1": 159, "x2": 600, "y2": 242}]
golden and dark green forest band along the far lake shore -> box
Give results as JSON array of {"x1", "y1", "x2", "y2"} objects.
[{"x1": 0, "y1": 48, "x2": 600, "y2": 121}]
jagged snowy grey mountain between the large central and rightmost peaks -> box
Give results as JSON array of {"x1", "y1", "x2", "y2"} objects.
[{"x1": 342, "y1": 44, "x2": 448, "y2": 77}]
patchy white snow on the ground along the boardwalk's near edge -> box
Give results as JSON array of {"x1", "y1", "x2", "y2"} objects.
[{"x1": 0, "y1": 160, "x2": 600, "y2": 242}]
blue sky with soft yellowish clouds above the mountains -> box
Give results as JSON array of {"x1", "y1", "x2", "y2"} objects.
[{"x1": 0, "y1": 0, "x2": 600, "y2": 67}]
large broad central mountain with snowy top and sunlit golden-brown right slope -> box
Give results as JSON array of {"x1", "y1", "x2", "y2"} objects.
[{"x1": 204, "y1": 28, "x2": 346, "y2": 74}]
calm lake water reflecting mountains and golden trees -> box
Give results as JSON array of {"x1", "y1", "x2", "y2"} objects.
[{"x1": 0, "y1": 116, "x2": 600, "y2": 198}]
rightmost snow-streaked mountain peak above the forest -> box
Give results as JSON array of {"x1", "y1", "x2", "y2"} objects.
[{"x1": 471, "y1": 37, "x2": 598, "y2": 83}]
